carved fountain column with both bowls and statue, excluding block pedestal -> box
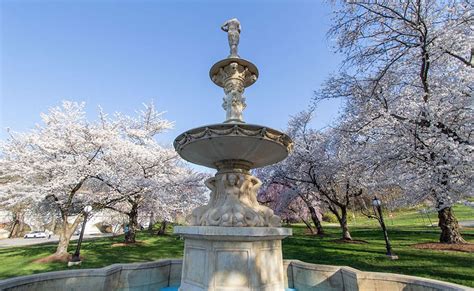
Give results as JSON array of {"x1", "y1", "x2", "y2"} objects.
[{"x1": 174, "y1": 18, "x2": 293, "y2": 227}]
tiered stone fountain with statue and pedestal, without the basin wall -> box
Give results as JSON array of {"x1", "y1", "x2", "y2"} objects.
[{"x1": 174, "y1": 18, "x2": 293, "y2": 291}]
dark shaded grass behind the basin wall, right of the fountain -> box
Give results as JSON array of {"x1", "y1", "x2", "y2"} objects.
[{"x1": 283, "y1": 227, "x2": 474, "y2": 286}]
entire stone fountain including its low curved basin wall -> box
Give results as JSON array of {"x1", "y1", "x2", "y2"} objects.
[{"x1": 0, "y1": 19, "x2": 472, "y2": 291}]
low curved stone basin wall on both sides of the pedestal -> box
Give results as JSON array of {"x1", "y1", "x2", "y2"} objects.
[{"x1": 0, "y1": 259, "x2": 474, "y2": 291}]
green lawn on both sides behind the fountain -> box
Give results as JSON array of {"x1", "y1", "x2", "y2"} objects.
[{"x1": 0, "y1": 206, "x2": 474, "y2": 287}]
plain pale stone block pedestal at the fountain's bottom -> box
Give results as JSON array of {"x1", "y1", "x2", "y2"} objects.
[{"x1": 174, "y1": 226, "x2": 291, "y2": 291}]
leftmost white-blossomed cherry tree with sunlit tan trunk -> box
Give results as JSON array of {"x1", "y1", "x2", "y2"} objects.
[{"x1": 1, "y1": 102, "x2": 107, "y2": 256}]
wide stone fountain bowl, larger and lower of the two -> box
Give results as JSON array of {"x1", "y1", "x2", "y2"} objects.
[{"x1": 174, "y1": 123, "x2": 293, "y2": 169}]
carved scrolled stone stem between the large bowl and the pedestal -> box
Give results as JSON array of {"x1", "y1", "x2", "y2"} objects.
[{"x1": 187, "y1": 172, "x2": 280, "y2": 227}]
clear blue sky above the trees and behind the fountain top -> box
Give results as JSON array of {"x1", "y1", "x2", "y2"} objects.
[{"x1": 0, "y1": 0, "x2": 340, "y2": 143}]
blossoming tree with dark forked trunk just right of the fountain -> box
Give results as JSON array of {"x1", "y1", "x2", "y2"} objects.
[{"x1": 285, "y1": 117, "x2": 364, "y2": 240}]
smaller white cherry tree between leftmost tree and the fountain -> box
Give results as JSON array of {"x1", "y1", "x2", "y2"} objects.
[{"x1": 95, "y1": 154, "x2": 205, "y2": 243}]
